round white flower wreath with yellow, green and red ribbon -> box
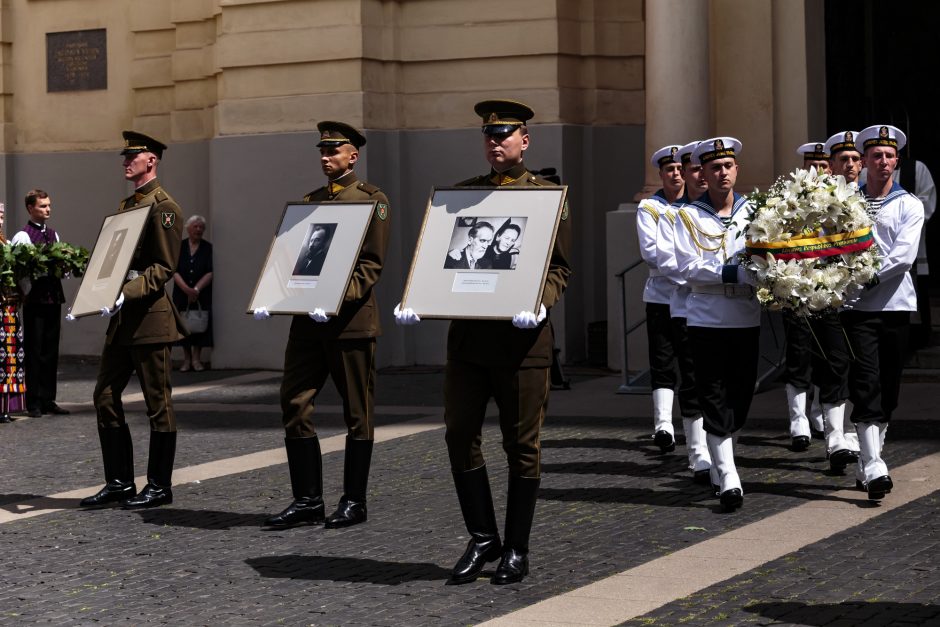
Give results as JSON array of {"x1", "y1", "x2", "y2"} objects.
[{"x1": 742, "y1": 168, "x2": 881, "y2": 315}]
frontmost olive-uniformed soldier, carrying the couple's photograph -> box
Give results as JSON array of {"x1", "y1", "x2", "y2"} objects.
[{"x1": 396, "y1": 100, "x2": 571, "y2": 584}]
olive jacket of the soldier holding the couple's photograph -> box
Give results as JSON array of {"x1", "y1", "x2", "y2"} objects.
[{"x1": 447, "y1": 163, "x2": 571, "y2": 368}]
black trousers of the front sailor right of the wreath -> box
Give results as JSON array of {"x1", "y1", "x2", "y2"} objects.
[{"x1": 841, "y1": 311, "x2": 911, "y2": 422}]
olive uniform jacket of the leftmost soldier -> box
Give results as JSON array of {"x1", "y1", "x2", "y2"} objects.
[{"x1": 107, "y1": 179, "x2": 187, "y2": 345}]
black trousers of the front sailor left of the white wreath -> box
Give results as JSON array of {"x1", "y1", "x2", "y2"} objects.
[{"x1": 689, "y1": 326, "x2": 760, "y2": 436}]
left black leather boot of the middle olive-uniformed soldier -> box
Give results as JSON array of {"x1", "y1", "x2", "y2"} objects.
[{"x1": 263, "y1": 436, "x2": 324, "y2": 529}]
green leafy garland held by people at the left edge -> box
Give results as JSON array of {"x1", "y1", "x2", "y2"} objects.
[{"x1": 0, "y1": 242, "x2": 89, "y2": 289}]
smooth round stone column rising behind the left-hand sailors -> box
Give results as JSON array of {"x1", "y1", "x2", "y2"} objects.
[{"x1": 637, "y1": 0, "x2": 711, "y2": 199}]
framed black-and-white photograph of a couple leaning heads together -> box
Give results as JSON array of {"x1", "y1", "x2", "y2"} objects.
[{"x1": 402, "y1": 186, "x2": 568, "y2": 320}]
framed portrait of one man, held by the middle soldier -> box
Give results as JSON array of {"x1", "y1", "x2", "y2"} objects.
[{"x1": 248, "y1": 201, "x2": 376, "y2": 316}]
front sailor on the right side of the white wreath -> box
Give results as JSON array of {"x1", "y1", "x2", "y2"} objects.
[{"x1": 841, "y1": 125, "x2": 924, "y2": 500}]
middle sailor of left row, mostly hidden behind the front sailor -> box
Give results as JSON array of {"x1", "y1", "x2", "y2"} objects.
[{"x1": 656, "y1": 141, "x2": 718, "y2": 485}]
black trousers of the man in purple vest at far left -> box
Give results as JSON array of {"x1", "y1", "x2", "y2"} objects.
[{"x1": 23, "y1": 303, "x2": 62, "y2": 409}]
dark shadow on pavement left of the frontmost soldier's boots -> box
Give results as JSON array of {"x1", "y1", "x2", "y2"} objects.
[{"x1": 245, "y1": 555, "x2": 450, "y2": 586}]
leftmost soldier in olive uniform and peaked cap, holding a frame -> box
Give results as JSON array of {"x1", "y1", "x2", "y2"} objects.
[{"x1": 81, "y1": 131, "x2": 185, "y2": 508}]
